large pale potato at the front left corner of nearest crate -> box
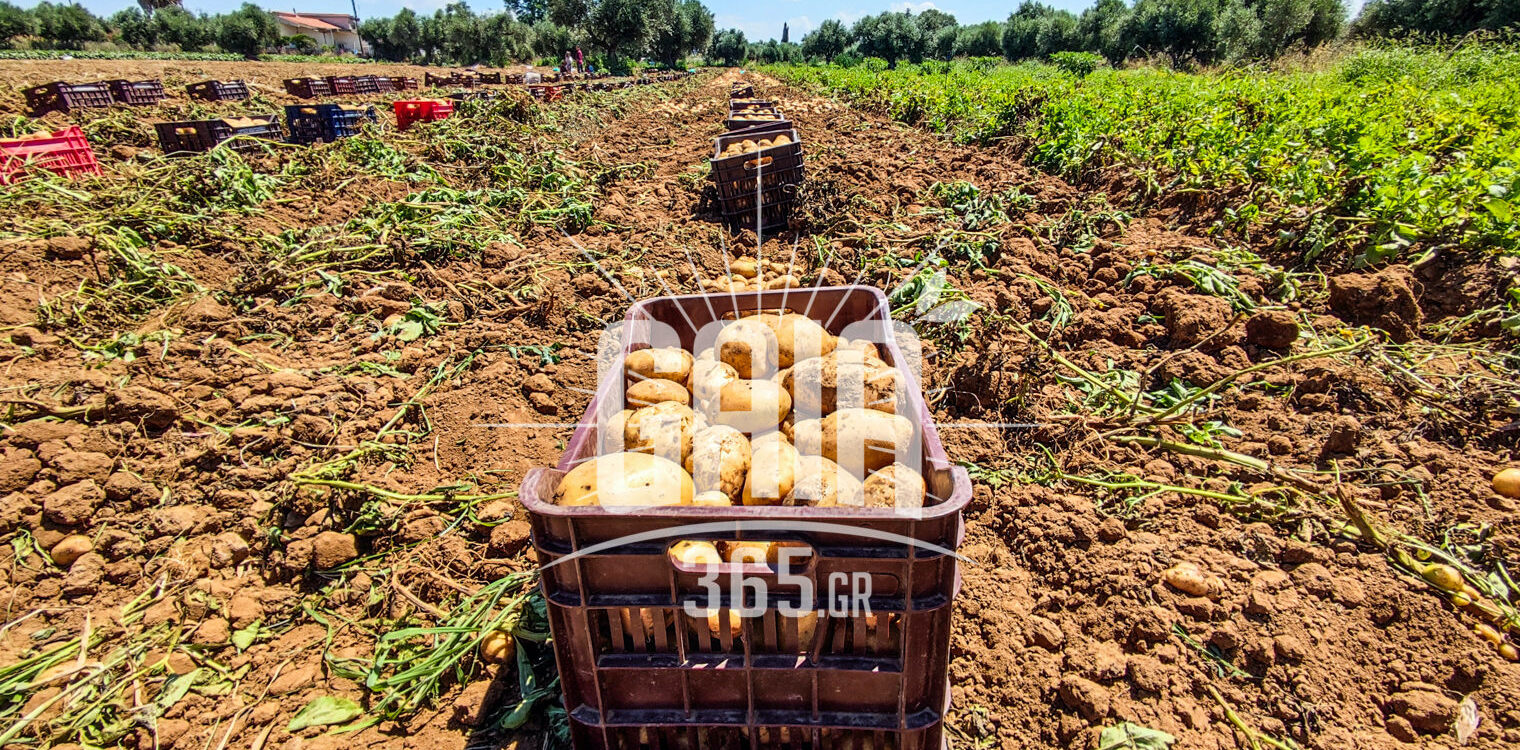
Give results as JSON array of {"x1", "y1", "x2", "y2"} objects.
[{"x1": 555, "y1": 453, "x2": 692, "y2": 507}]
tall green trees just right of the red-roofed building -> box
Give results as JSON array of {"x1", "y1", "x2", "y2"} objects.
[{"x1": 359, "y1": 0, "x2": 713, "y2": 72}]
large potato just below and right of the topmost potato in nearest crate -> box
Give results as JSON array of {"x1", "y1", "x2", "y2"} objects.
[{"x1": 781, "y1": 350, "x2": 904, "y2": 418}]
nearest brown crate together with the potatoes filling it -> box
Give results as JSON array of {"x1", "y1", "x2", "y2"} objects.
[{"x1": 521, "y1": 284, "x2": 970, "y2": 748}]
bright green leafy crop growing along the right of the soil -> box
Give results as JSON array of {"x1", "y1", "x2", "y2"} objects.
[{"x1": 771, "y1": 46, "x2": 1520, "y2": 263}]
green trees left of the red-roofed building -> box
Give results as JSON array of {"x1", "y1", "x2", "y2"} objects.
[{"x1": 0, "y1": 2, "x2": 282, "y2": 56}]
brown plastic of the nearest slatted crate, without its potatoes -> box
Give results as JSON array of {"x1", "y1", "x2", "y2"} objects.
[{"x1": 520, "y1": 286, "x2": 971, "y2": 750}]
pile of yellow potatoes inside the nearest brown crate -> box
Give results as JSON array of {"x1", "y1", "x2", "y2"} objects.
[{"x1": 555, "y1": 308, "x2": 926, "y2": 508}]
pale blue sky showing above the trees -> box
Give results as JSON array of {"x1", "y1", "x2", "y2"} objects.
[{"x1": 38, "y1": 0, "x2": 1362, "y2": 41}]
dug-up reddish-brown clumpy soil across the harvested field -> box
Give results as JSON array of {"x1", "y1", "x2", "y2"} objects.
[{"x1": 0, "y1": 61, "x2": 1520, "y2": 748}]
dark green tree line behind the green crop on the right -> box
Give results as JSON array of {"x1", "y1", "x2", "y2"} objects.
[{"x1": 707, "y1": 0, "x2": 1520, "y2": 65}]
